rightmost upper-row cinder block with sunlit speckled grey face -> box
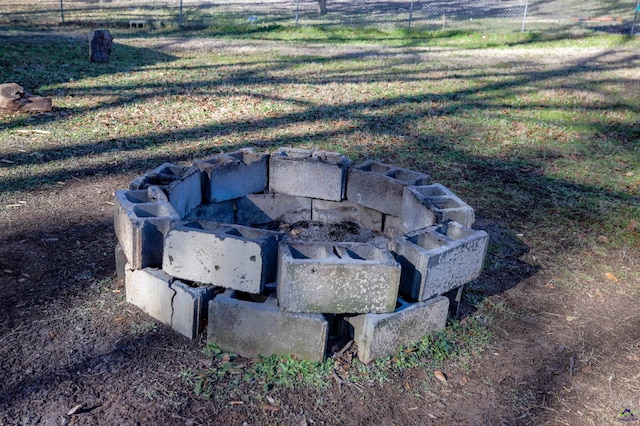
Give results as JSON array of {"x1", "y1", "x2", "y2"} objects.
[{"x1": 391, "y1": 222, "x2": 489, "y2": 301}]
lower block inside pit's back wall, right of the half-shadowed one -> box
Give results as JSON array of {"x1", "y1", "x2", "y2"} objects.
[{"x1": 311, "y1": 199, "x2": 382, "y2": 232}]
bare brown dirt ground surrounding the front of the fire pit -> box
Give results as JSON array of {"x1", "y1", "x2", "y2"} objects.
[{"x1": 0, "y1": 38, "x2": 640, "y2": 425}]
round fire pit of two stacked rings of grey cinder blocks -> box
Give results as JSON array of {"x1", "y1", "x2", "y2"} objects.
[{"x1": 115, "y1": 148, "x2": 488, "y2": 362}]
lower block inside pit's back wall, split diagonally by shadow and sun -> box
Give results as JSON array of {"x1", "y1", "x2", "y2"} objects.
[{"x1": 234, "y1": 193, "x2": 311, "y2": 226}]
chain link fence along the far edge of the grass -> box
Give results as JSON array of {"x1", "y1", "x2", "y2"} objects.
[{"x1": 0, "y1": 0, "x2": 640, "y2": 34}]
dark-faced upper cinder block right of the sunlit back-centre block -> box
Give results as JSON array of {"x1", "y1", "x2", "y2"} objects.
[{"x1": 347, "y1": 160, "x2": 430, "y2": 217}]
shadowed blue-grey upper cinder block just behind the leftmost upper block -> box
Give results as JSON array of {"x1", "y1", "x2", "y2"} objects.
[{"x1": 130, "y1": 163, "x2": 202, "y2": 218}]
